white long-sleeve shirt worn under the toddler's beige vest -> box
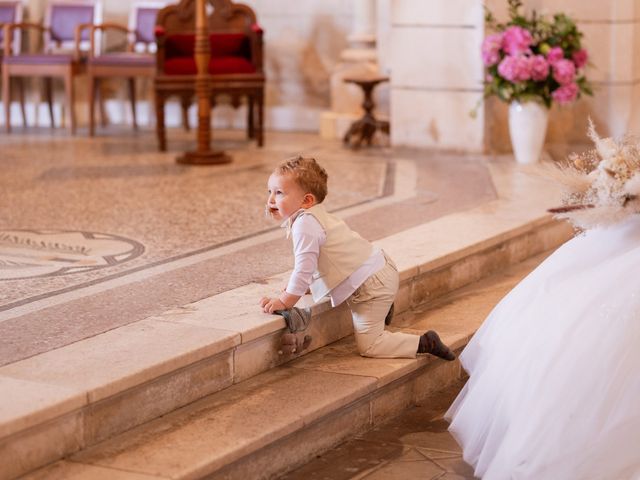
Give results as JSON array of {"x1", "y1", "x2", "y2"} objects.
[{"x1": 286, "y1": 214, "x2": 385, "y2": 307}]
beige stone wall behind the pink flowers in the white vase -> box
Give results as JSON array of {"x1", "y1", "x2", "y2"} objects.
[{"x1": 485, "y1": 0, "x2": 640, "y2": 156}]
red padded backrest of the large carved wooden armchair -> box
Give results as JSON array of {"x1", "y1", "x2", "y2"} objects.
[{"x1": 165, "y1": 33, "x2": 251, "y2": 58}]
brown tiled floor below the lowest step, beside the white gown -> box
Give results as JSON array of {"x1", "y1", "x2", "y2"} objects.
[{"x1": 280, "y1": 384, "x2": 475, "y2": 480}]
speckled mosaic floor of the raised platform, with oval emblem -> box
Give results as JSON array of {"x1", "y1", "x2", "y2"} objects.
[{"x1": 0, "y1": 128, "x2": 500, "y2": 365}]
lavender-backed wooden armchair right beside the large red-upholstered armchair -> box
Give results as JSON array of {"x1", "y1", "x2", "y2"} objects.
[{"x1": 87, "y1": 2, "x2": 166, "y2": 136}]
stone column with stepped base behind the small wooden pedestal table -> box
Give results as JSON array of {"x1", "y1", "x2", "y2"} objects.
[{"x1": 320, "y1": 0, "x2": 379, "y2": 138}]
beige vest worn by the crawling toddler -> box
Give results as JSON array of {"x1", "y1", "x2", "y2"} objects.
[{"x1": 299, "y1": 203, "x2": 373, "y2": 302}]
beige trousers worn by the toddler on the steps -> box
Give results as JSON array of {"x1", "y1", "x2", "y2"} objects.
[{"x1": 347, "y1": 254, "x2": 420, "y2": 358}]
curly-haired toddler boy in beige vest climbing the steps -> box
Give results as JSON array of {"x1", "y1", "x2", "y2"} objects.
[{"x1": 260, "y1": 157, "x2": 455, "y2": 361}]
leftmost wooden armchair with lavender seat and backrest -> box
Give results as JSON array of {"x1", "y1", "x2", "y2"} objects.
[{"x1": 2, "y1": 0, "x2": 102, "y2": 134}]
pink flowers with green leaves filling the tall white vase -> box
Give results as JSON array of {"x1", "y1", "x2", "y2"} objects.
[{"x1": 482, "y1": 0, "x2": 592, "y2": 107}]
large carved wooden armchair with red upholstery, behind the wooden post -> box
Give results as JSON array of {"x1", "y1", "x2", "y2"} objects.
[{"x1": 154, "y1": 0, "x2": 265, "y2": 151}]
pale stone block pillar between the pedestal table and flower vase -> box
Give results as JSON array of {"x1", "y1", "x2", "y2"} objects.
[{"x1": 389, "y1": 0, "x2": 484, "y2": 152}]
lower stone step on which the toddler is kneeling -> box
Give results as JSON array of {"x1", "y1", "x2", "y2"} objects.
[{"x1": 26, "y1": 248, "x2": 546, "y2": 480}]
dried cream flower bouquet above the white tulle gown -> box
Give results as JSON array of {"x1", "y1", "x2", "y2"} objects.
[{"x1": 549, "y1": 122, "x2": 640, "y2": 229}]
